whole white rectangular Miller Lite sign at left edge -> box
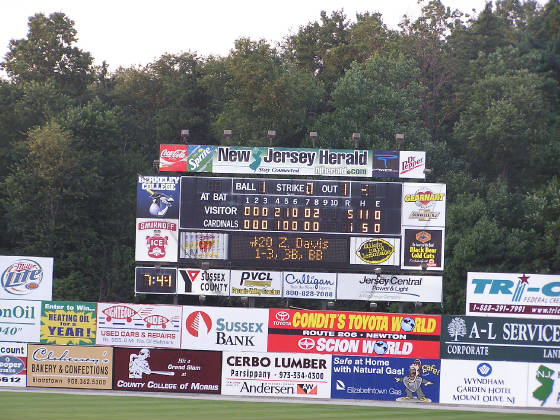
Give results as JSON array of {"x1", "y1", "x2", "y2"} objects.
[{"x1": 0, "y1": 255, "x2": 53, "y2": 300}]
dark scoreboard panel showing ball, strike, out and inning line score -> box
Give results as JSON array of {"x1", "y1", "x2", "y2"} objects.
[{"x1": 180, "y1": 177, "x2": 402, "y2": 236}]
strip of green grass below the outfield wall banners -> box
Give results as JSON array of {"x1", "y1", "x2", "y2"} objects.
[{"x1": 0, "y1": 391, "x2": 560, "y2": 420}]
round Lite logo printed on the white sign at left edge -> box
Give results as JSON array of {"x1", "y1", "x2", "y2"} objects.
[{"x1": 0, "y1": 259, "x2": 43, "y2": 295}]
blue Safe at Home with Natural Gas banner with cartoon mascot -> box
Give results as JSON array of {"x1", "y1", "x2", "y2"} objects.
[{"x1": 331, "y1": 356, "x2": 441, "y2": 403}]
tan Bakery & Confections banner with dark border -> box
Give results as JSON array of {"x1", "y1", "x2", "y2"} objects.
[{"x1": 27, "y1": 344, "x2": 113, "y2": 389}]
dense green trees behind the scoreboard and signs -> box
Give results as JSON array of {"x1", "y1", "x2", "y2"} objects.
[{"x1": 0, "y1": 0, "x2": 560, "y2": 313}]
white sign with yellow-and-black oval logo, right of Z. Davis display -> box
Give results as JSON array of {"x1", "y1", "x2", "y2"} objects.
[{"x1": 350, "y1": 237, "x2": 401, "y2": 267}]
